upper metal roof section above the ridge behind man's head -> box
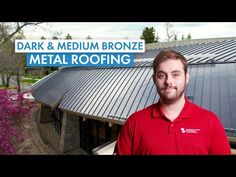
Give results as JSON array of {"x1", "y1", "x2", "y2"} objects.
[{"x1": 135, "y1": 39, "x2": 236, "y2": 64}]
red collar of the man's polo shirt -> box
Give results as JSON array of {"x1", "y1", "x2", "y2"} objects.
[{"x1": 152, "y1": 97, "x2": 193, "y2": 119}]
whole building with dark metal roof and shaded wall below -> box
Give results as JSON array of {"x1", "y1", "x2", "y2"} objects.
[{"x1": 32, "y1": 37, "x2": 236, "y2": 153}]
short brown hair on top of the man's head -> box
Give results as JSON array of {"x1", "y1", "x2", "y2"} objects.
[{"x1": 152, "y1": 50, "x2": 188, "y2": 75}]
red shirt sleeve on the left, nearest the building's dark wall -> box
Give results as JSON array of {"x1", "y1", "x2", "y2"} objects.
[{"x1": 113, "y1": 118, "x2": 133, "y2": 155}]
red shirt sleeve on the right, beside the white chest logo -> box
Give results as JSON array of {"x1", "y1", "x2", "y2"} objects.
[{"x1": 209, "y1": 117, "x2": 231, "y2": 155}]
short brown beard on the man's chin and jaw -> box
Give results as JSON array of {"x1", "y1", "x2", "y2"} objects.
[{"x1": 158, "y1": 83, "x2": 186, "y2": 104}]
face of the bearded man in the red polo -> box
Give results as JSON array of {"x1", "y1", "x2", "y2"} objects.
[{"x1": 153, "y1": 59, "x2": 189, "y2": 104}]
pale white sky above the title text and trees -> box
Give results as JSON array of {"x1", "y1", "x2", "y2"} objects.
[{"x1": 24, "y1": 22, "x2": 236, "y2": 42}]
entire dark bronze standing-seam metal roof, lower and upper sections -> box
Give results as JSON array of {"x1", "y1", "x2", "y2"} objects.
[{"x1": 32, "y1": 40, "x2": 236, "y2": 128}]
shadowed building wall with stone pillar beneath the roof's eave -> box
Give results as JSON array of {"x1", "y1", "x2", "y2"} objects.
[{"x1": 38, "y1": 105, "x2": 122, "y2": 154}]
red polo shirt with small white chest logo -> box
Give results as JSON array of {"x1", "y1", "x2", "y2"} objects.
[{"x1": 114, "y1": 99, "x2": 231, "y2": 155}]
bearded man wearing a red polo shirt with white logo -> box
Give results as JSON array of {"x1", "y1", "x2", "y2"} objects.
[{"x1": 114, "y1": 50, "x2": 231, "y2": 155}]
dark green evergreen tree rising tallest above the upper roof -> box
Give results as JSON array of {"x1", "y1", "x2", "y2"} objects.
[{"x1": 140, "y1": 27, "x2": 159, "y2": 44}]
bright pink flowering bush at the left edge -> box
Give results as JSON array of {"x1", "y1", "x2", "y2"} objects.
[{"x1": 0, "y1": 89, "x2": 34, "y2": 154}]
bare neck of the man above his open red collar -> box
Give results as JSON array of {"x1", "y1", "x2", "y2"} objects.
[{"x1": 160, "y1": 96, "x2": 185, "y2": 122}]
